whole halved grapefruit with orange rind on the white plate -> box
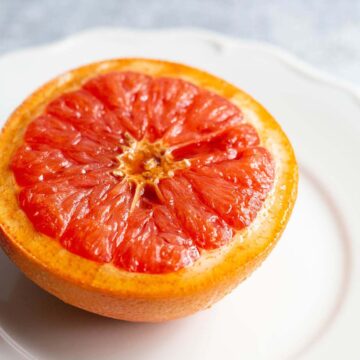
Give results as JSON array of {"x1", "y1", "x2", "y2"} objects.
[{"x1": 0, "y1": 59, "x2": 297, "y2": 321}]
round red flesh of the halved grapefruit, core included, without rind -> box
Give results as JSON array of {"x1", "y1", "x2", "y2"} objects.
[{"x1": 11, "y1": 72, "x2": 274, "y2": 273}]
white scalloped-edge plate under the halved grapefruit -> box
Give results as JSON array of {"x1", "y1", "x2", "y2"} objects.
[{"x1": 0, "y1": 29, "x2": 360, "y2": 360}]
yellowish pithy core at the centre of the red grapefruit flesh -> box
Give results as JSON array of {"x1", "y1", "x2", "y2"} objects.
[{"x1": 113, "y1": 136, "x2": 190, "y2": 184}]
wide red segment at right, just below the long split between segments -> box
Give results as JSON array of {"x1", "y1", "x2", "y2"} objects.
[{"x1": 183, "y1": 148, "x2": 274, "y2": 230}]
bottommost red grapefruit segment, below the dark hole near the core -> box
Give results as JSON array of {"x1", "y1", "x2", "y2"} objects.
[{"x1": 114, "y1": 204, "x2": 200, "y2": 274}]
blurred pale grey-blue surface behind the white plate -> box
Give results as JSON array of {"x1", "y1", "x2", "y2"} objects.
[{"x1": 0, "y1": 0, "x2": 360, "y2": 86}]
